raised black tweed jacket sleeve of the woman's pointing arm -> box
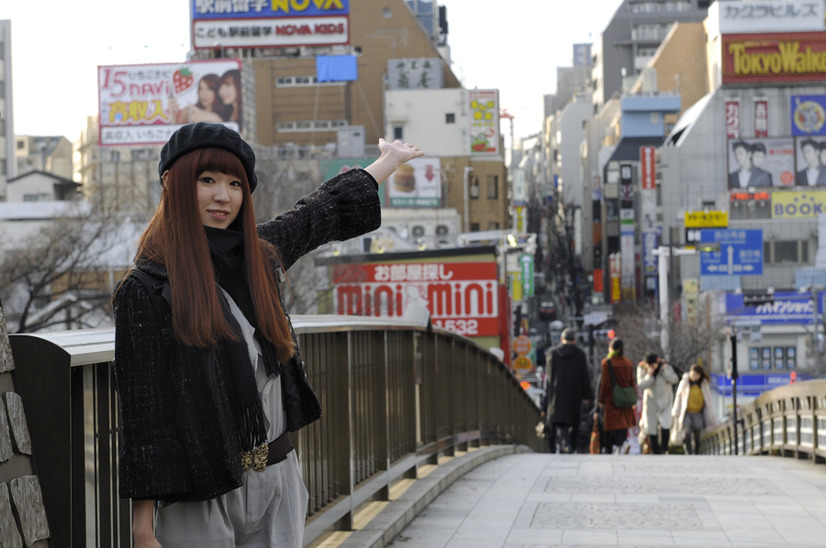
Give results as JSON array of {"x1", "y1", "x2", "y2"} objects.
[{"x1": 258, "y1": 169, "x2": 381, "y2": 270}]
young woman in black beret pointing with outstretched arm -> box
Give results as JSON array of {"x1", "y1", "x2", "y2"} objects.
[{"x1": 113, "y1": 123, "x2": 423, "y2": 548}]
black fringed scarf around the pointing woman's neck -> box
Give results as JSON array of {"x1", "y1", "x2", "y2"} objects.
[{"x1": 204, "y1": 227, "x2": 281, "y2": 451}]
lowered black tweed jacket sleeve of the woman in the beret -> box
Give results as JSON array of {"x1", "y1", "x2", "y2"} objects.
[{"x1": 114, "y1": 278, "x2": 187, "y2": 499}]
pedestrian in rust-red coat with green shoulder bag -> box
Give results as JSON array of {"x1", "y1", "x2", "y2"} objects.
[{"x1": 598, "y1": 339, "x2": 635, "y2": 448}]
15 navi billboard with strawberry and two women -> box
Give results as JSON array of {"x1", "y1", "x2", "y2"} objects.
[{"x1": 98, "y1": 59, "x2": 243, "y2": 145}]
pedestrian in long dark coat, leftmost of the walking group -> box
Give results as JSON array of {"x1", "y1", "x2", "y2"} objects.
[{"x1": 541, "y1": 327, "x2": 594, "y2": 453}]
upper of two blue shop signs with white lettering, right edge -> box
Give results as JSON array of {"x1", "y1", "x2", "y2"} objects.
[{"x1": 723, "y1": 291, "x2": 826, "y2": 325}]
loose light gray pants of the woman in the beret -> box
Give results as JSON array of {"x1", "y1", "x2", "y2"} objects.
[{"x1": 155, "y1": 451, "x2": 308, "y2": 548}]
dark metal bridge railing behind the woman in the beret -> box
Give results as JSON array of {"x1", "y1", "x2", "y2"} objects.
[{"x1": 9, "y1": 316, "x2": 545, "y2": 547}]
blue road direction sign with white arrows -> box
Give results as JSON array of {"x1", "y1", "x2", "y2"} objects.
[{"x1": 700, "y1": 228, "x2": 763, "y2": 276}]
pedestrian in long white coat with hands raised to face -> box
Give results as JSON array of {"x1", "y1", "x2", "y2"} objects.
[{"x1": 637, "y1": 352, "x2": 679, "y2": 455}]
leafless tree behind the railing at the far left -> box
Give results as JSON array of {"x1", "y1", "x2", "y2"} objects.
[{"x1": 0, "y1": 204, "x2": 129, "y2": 333}]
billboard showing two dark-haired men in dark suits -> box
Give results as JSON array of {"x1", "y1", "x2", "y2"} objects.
[{"x1": 728, "y1": 138, "x2": 795, "y2": 190}]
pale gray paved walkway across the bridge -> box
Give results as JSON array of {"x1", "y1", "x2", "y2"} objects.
[{"x1": 314, "y1": 449, "x2": 826, "y2": 548}]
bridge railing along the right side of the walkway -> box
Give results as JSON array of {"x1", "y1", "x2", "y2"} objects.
[{"x1": 700, "y1": 380, "x2": 826, "y2": 463}]
